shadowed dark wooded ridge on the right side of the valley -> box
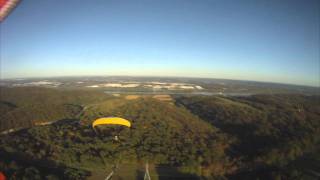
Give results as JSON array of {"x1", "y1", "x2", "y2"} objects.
[{"x1": 177, "y1": 95, "x2": 320, "y2": 179}]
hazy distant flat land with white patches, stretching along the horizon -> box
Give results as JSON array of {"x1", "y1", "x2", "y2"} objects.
[{"x1": 0, "y1": 76, "x2": 320, "y2": 96}]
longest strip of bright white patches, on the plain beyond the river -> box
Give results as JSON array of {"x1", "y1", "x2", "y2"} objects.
[{"x1": 86, "y1": 82, "x2": 204, "y2": 90}]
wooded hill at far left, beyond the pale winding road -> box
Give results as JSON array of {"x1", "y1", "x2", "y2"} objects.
[{"x1": 0, "y1": 87, "x2": 110, "y2": 132}]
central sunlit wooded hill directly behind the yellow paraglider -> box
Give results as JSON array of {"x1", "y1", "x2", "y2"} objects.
[{"x1": 0, "y1": 87, "x2": 234, "y2": 178}]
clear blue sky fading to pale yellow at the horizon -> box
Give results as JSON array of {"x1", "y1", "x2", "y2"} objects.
[{"x1": 1, "y1": 0, "x2": 320, "y2": 86}]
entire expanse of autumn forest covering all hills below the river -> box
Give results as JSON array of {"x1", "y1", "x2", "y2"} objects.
[{"x1": 0, "y1": 87, "x2": 320, "y2": 179}]
